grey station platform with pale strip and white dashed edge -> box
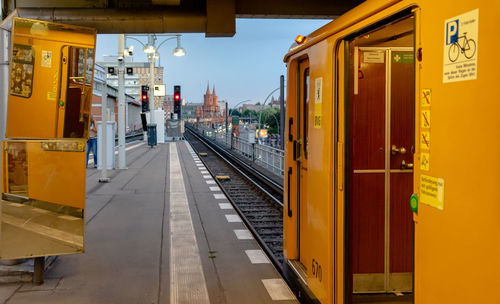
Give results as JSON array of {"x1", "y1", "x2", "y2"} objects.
[{"x1": 0, "y1": 141, "x2": 297, "y2": 304}]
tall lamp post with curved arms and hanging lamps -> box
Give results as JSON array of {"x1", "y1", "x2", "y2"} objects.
[{"x1": 126, "y1": 34, "x2": 186, "y2": 145}]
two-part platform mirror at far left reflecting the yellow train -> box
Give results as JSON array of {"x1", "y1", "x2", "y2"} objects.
[{"x1": 0, "y1": 17, "x2": 96, "y2": 259}]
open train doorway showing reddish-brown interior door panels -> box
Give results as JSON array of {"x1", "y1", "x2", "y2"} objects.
[{"x1": 347, "y1": 18, "x2": 415, "y2": 303}]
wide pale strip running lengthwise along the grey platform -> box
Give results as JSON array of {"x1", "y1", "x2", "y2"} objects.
[{"x1": 169, "y1": 142, "x2": 210, "y2": 304}]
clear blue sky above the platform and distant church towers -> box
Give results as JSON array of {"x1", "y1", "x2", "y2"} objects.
[{"x1": 96, "y1": 19, "x2": 329, "y2": 106}]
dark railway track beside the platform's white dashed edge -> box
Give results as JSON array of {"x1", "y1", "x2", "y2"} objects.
[{"x1": 184, "y1": 128, "x2": 283, "y2": 271}]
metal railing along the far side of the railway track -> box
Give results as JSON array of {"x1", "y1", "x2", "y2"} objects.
[{"x1": 195, "y1": 126, "x2": 285, "y2": 176}]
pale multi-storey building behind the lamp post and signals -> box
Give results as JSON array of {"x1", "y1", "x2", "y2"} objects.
[{"x1": 97, "y1": 55, "x2": 166, "y2": 108}]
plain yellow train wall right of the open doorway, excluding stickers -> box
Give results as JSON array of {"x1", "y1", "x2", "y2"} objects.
[{"x1": 415, "y1": 1, "x2": 500, "y2": 303}]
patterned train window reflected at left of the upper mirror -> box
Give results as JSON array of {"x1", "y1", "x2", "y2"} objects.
[{"x1": 10, "y1": 44, "x2": 35, "y2": 98}]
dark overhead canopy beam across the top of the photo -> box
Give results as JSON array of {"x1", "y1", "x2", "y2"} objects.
[{"x1": 1, "y1": 0, "x2": 363, "y2": 37}]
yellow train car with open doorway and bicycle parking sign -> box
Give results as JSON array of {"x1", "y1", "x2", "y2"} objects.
[{"x1": 284, "y1": 0, "x2": 500, "y2": 304}]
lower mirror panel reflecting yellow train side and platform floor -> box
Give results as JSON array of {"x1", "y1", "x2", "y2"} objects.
[{"x1": 0, "y1": 140, "x2": 85, "y2": 259}]
